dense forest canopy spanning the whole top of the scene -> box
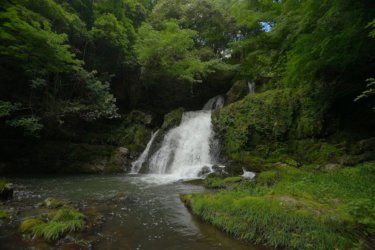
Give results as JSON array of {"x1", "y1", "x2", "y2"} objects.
[{"x1": 0, "y1": 0, "x2": 375, "y2": 139}]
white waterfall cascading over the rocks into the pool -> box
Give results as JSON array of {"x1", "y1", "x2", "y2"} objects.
[{"x1": 133, "y1": 96, "x2": 224, "y2": 181}]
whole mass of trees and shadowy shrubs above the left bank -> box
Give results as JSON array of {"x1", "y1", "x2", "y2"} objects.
[{"x1": 0, "y1": 0, "x2": 120, "y2": 137}]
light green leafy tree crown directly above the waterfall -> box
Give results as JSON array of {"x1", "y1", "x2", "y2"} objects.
[{"x1": 135, "y1": 20, "x2": 215, "y2": 82}]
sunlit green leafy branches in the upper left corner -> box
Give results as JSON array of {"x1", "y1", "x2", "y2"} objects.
[{"x1": 0, "y1": 5, "x2": 82, "y2": 76}]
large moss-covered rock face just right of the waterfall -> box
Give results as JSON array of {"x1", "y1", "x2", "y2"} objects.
[{"x1": 213, "y1": 89, "x2": 368, "y2": 171}]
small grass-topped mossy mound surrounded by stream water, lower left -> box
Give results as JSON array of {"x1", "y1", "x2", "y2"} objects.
[{"x1": 20, "y1": 208, "x2": 85, "y2": 241}]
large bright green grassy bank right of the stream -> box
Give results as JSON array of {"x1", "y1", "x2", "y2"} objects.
[{"x1": 182, "y1": 162, "x2": 375, "y2": 249}]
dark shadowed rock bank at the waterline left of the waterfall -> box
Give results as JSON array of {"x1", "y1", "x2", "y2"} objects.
[{"x1": 0, "y1": 142, "x2": 132, "y2": 174}]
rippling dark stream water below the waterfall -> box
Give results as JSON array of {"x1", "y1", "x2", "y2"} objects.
[{"x1": 0, "y1": 175, "x2": 266, "y2": 250}]
